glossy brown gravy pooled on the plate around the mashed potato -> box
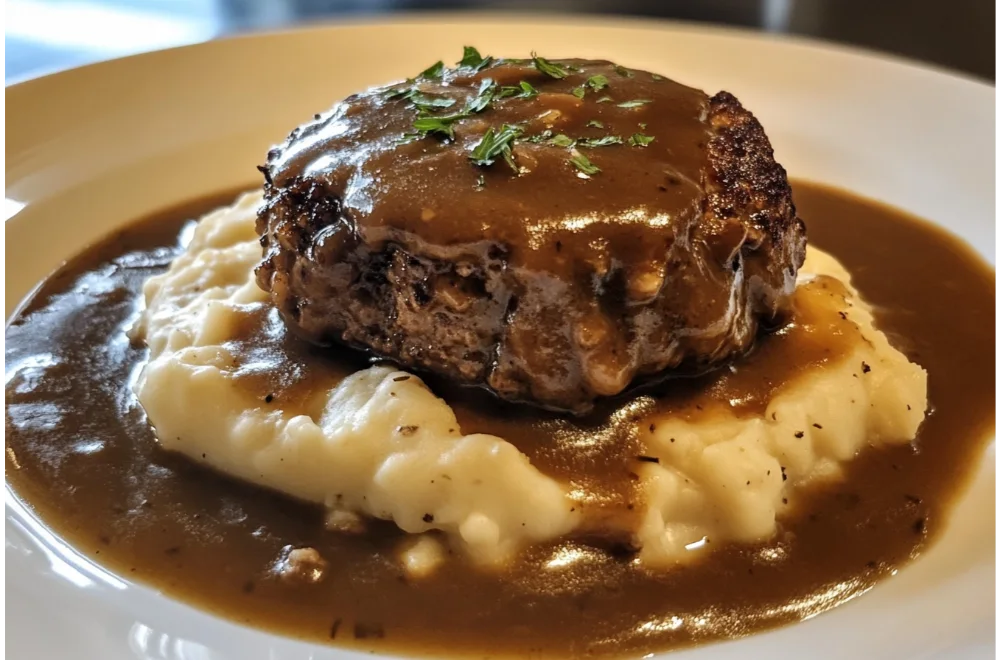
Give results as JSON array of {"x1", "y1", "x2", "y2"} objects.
[{"x1": 4, "y1": 182, "x2": 996, "y2": 657}]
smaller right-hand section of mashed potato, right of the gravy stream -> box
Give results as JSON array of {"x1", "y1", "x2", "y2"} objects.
[{"x1": 638, "y1": 248, "x2": 927, "y2": 565}]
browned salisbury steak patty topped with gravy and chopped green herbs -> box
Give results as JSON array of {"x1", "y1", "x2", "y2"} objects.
[{"x1": 257, "y1": 49, "x2": 805, "y2": 413}]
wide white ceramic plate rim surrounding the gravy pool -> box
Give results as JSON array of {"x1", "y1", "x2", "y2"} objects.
[{"x1": 0, "y1": 15, "x2": 1000, "y2": 660}]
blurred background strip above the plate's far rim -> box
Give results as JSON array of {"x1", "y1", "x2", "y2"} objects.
[{"x1": 0, "y1": 0, "x2": 997, "y2": 81}]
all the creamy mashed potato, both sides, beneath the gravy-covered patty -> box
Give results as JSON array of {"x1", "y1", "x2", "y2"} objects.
[{"x1": 129, "y1": 195, "x2": 926, "y2": 575}]
